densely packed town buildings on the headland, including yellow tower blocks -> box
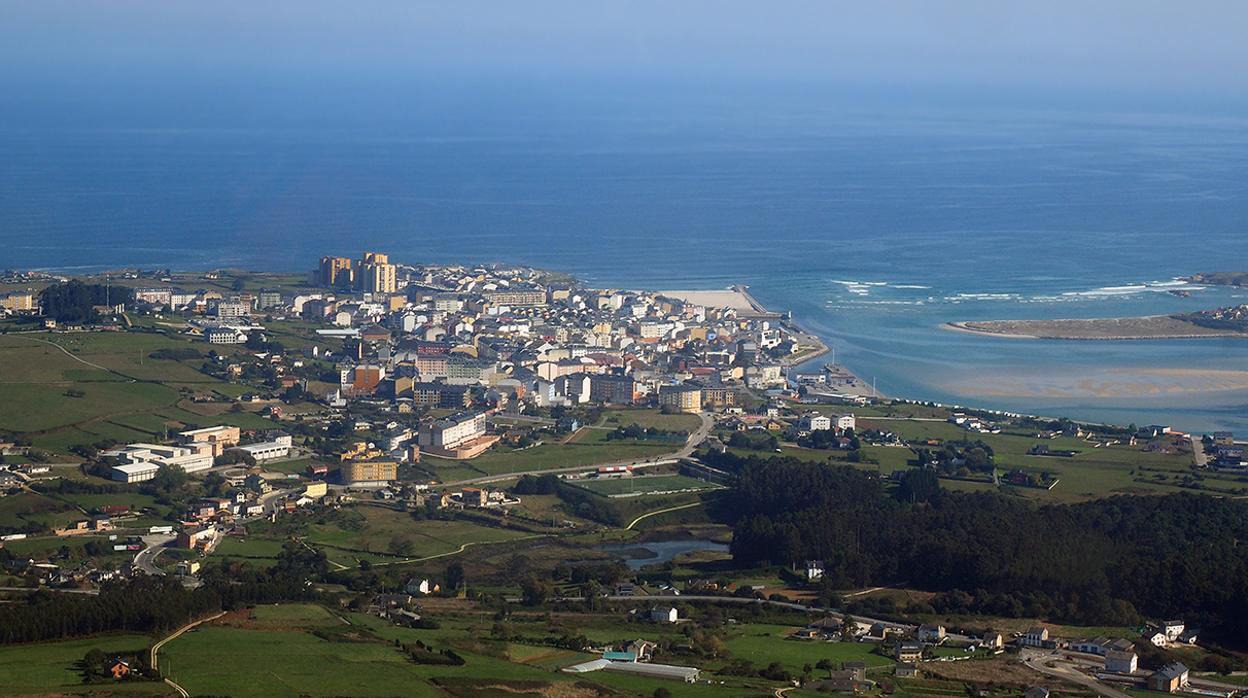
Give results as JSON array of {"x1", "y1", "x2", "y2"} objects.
[{"x1": 299, "y1": 252, "x2": 799, "y2": 417}]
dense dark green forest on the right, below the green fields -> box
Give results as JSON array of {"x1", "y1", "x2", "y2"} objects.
[{"x1": 714, "y1": 453, "x2": 1248, "y2": 643}]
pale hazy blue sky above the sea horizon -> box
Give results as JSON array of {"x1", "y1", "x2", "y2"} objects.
[{"x1": 0, "y1": 0, "x2": 1248, "y2": 95}]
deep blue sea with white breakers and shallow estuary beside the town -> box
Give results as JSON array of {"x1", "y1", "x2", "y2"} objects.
[{"x1": 0, "y1": 86, "x2": 1248, "y2": 433}]
